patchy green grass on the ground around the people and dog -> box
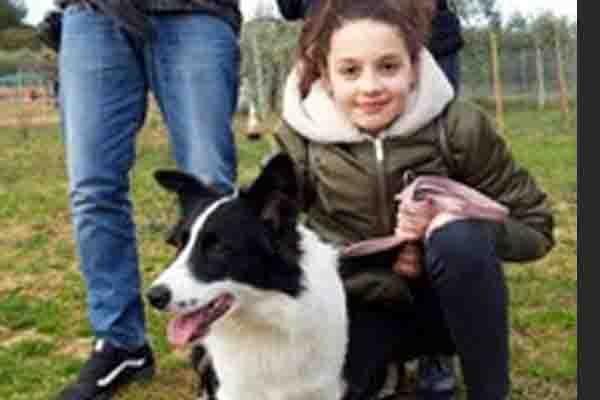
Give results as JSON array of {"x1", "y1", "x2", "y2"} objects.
[{"x1": 0, "y1": 101, "x2": 577, "y2": 400}]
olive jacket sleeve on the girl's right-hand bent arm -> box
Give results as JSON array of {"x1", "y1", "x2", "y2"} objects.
[{"x1": 448, "y1": 102, "x2": 554, "y2": 262}]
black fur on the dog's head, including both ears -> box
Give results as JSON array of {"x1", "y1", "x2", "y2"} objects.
[{"x1": 155, "y1": 156, "x2": 303, "y2": 296}]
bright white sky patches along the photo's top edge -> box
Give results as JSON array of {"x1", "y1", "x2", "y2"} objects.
[{"x1": 25, "y1": 0, "x2": 577, "y2": 25}]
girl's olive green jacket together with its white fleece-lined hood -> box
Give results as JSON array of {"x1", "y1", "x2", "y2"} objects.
[{"x1": 275, "y1": 50, "x2": 554, "y2": 306}]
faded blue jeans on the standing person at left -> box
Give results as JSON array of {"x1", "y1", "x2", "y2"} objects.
[{"x1": 59, "y1": 5, "x2": 239, "y2": 347}]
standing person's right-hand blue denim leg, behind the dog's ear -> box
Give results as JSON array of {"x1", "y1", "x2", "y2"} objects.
[{"x1": 146, "y1": 13, "x2": 239, "y2": 192}]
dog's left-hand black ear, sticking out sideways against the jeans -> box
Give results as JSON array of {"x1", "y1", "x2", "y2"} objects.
[{"x1": 154, "y1": 170, "x2": 220, "y2": 216}]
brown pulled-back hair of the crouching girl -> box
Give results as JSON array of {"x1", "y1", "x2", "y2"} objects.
[{"x1": 298, "y1": 0, "x2": 435, "y2": 97}]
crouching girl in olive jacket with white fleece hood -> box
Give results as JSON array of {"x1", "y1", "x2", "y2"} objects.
[{"x1": 276, "y1": 0, "x2": 554, "y2": 400}]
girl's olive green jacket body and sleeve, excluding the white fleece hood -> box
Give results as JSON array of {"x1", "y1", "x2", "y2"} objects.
[{"x1": 275, "y1": 101, "x2": 554, "y2": 261}]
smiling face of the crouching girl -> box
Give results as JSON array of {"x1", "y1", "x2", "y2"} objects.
[{"x1": 323, "y1": 20, "x2": 416, "y2": 134}]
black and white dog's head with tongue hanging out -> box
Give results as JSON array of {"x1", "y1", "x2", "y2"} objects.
[{"x1": 147, "y1": 155, "x2": 303, "y2": 345}]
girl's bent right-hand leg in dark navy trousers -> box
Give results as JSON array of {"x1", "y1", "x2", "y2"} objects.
[{"x1": 425, "y1": 221, "x2": 510, "y2": 400}]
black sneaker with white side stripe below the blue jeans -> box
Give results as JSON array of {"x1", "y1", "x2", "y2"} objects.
[{"x1": 56, "y1": 340, "x2": 154, "y2": 400}]
